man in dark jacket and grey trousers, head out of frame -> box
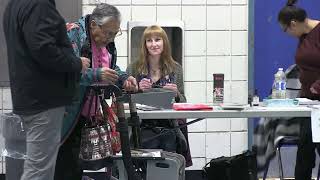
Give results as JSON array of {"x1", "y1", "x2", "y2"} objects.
[{"x1": 3, "y1": 0, "x2": 89, "y2": 180}]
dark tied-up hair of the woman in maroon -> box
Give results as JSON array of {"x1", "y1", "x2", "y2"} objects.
[{"x1": 278, "y1": 0, "x2": 307, "y2": 25}]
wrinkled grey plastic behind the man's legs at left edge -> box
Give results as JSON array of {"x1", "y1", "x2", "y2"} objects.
[{"x1": 0, "y1": 112, "x2": 26, "y2": 159}]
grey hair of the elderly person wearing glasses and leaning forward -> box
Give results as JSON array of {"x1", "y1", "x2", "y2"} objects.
[{"x1": 90, "y1": 3, "x2": 121, "y2": 25}]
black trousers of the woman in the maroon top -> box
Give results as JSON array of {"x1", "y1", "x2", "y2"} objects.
[{"x1": 295, "y1": 118, "x2": 320, "y2": 180}]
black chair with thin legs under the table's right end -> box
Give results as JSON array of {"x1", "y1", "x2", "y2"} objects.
[{"x1": 263, "y1": 136, "x2": 320, "y2": 180}]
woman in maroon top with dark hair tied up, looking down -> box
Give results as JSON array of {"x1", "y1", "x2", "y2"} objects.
[{"x1": 278, "y1": 0, "x2": 320, "y2": 180}]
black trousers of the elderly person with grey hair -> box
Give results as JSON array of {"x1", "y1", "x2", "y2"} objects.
[{"x1": 54, "y1": 119, "x2": 84, "y2": 180}]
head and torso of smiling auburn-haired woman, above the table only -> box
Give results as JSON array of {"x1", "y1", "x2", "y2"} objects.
[{"x1": 128, "y1": 25, "x2": 185, "y2": 97}]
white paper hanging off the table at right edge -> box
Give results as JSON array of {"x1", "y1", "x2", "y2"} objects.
[{"x1": 311, "y1": 105, "x2": 320, "y2": 143}]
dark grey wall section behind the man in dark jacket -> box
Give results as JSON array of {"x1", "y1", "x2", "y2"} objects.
[{"x1": 0, "y1": 0, "x2": 82, "y2": 87}]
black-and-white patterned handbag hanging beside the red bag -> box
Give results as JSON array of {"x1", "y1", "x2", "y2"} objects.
[{"x1": 79, "y1": 89, "x2": 113, "y2": 161}]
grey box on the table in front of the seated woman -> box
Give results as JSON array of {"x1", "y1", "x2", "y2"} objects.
[{"x1": 131, "y1": 88, "x2": 176, "y2": 109}]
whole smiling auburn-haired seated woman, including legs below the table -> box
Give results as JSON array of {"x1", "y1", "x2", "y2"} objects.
[{"x1": 127, "y1": 25, "x2": 192, "y2": 166}]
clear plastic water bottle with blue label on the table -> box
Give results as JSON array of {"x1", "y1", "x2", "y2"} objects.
[{"x1": 272, "y1": 68, "x2": 286, "y2": 99}]
